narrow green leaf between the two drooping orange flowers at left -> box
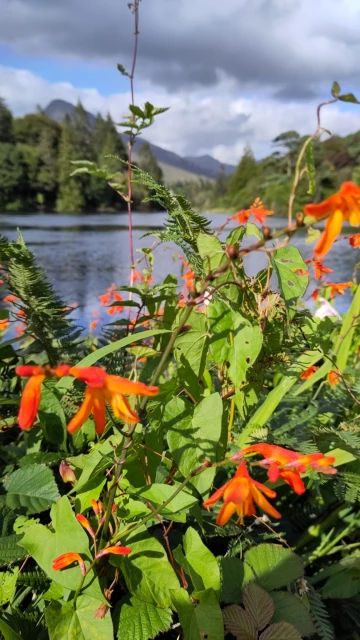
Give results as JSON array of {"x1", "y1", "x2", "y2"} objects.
[{"x1": 39, "y1": 384, "x2": 66, "y2": 445}]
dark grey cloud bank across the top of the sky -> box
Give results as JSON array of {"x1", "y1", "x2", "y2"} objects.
[{"x1": 0, "y1": 0, "x2": 360, "y2": 99}]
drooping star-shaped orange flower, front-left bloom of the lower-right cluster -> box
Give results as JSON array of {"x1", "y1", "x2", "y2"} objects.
[{"x1": 204, "y1": 460, "x2": 281, "y2": 526}]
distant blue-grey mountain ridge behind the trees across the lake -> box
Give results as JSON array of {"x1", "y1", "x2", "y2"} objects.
[{"x1": 44, "y1": 100, "x2": 235, "y2": 182}]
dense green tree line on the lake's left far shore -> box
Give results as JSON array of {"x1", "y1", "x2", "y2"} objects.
[{"x1": 0, "y1": 98, "x2": 162, "y2": 212}]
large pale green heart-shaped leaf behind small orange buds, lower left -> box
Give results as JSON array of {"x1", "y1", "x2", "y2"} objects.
[{"x1": 20, "y1": 496, "x2": 102, "y2": 599}]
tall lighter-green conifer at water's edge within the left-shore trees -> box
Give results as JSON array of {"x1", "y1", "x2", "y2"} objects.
[{"x1": 56, "y1": 118, "x2": 85, "y2": 212}]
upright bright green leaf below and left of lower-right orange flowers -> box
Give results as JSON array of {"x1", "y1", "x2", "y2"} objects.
[{"x1": 183, "y1": 527, "x2": 220, "y2": 595}]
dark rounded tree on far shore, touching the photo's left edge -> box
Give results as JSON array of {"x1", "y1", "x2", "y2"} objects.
[{"x1": 0, "y1": 142, "x2": 28, "y2": 211}]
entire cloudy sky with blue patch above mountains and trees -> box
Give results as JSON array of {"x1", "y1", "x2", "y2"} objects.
[{"x1": 0, "y1": 0, "x2": 360, "y2": 164}]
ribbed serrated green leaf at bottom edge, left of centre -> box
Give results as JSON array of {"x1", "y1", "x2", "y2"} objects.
[{"x1": 114, "y1": 596, "x2": 172, "y2": 640}]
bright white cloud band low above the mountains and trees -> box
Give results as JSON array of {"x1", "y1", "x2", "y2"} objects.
[{"x1": 0, "y1": 66, "x2": 360, "y2": 163}]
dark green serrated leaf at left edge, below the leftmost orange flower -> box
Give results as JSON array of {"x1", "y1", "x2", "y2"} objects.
[{"x1": 2, "y1": 464, "x2": 60, "y2": 513}]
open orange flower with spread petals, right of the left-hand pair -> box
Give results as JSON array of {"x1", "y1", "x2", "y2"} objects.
[{"x1": 67, "y1": 367, "x2": 159, "y2": 435}]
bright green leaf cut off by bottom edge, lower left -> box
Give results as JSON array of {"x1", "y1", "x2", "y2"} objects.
[{"x1": 45, "y1": 596, "x2": 114, "y2": 640}]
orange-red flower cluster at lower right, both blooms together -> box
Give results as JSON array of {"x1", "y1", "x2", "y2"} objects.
[{"x1": 204, "y1": 443, "x2": 336, "y2": 526}]
